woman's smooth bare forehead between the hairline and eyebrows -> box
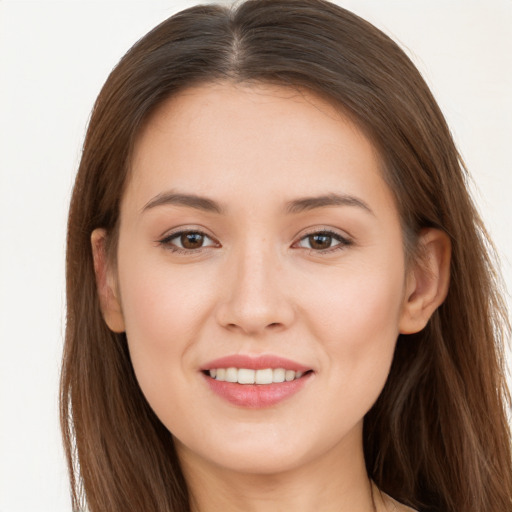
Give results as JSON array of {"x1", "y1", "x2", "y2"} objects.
[{"x1": 127, "y1": 83, "x2": 389, "y2": 216}]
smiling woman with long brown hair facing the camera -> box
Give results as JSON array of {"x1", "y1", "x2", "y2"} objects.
[{"x1": 61, "y1": 0, "x2": 512, "y2": 512}]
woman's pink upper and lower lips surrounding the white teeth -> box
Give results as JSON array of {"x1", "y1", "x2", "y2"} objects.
[{"x1": 201, "y1": 354, "x2": 313, "y2": 409}]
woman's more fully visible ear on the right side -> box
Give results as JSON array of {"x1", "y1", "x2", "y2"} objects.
[{"x1": 399, "y1": 228, "x2": 451, "y2": 334}]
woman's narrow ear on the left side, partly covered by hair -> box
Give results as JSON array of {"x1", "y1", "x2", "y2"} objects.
[{"x1": 91, "y1": 229, "x2": 125, "y2": 332}]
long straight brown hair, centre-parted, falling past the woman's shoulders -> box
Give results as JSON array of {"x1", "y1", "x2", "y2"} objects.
[{"x1": 61, "y1": 0, "x2": 512, "y2": 512}]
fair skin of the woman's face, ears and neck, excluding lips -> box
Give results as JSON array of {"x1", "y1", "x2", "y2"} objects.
[{"x1": 92, "y1": 83, "x2": 449, "y2": 512}]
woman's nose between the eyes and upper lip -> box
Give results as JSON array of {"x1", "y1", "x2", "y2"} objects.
[{"x1": 217, "y1": 246, "x2": 295, "y2": 336}]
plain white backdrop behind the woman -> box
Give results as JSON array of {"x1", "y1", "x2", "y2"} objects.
[{"x1": 0, "y1": 0, "x2": 512, "y2": 512}]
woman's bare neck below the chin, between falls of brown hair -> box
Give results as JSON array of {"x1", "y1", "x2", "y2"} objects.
[{"x1": 177, "y1": 428, "x2": 380, "y2": 512}]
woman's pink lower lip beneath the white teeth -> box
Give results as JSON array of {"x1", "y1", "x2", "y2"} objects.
[{"x1": 204, "y1": 373, "x2": 311, "y2": 409}]
